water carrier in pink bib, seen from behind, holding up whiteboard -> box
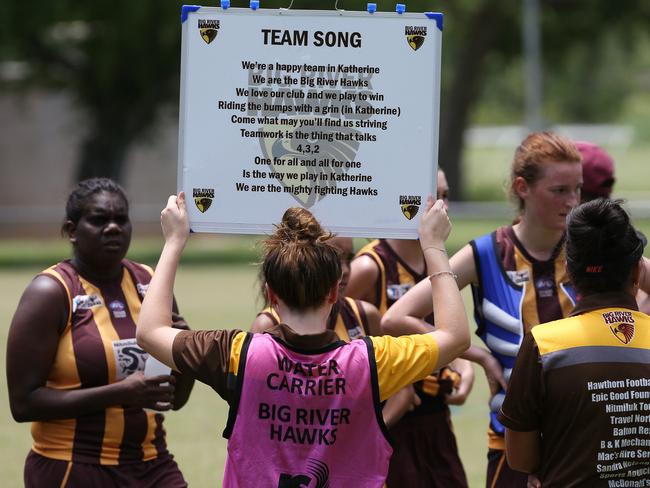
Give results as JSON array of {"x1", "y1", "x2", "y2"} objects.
[{"x1": 138, "y1": 193, "x2": 469, "y2": 487}]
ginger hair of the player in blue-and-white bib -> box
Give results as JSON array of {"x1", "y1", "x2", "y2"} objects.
[{"x1": 510, "y1": 132, "x2": 582, "y2": 211}]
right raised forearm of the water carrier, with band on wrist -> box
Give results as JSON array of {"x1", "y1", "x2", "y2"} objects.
[{"x1": 418, "y1": 198, "x2": 470, "y2": 368}]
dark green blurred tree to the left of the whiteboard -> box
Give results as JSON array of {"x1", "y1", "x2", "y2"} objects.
[{"x1": 0, "y1": 0, "x2": 181, "y2": 180}]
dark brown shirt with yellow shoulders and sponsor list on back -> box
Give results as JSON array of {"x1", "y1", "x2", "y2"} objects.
[{"x1": 499, "y1": 293, "x2": 650, "y2": 488}]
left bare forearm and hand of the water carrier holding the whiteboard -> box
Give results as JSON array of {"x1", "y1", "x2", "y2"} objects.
[{"x1": 136, "y1": 192, "x2": 190, "y2": 370}]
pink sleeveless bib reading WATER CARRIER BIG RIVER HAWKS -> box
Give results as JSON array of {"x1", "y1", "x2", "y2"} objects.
[{"x1": 223, "y1": 334, "x2": 392, "y2": 488}]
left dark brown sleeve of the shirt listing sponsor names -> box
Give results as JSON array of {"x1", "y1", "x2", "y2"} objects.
[{"x1": 499, "y1": 333, "x2": 544, "y2": 432}]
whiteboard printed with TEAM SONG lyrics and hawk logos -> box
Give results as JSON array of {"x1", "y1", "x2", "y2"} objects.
[{"x1": 178, "y1": 6, "x2": 442, "y2": 239}]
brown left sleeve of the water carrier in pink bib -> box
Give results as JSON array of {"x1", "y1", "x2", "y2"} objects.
[{"x1": 172, "y1": 330, "x2": 241, "y2": 401}]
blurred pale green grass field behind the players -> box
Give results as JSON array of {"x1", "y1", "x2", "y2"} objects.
[{"x1": 0, "y1": 139, "x2": 650, "y2": 487}]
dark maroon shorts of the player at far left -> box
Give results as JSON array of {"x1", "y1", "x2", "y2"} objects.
[{"x1": 24, "y1": 451, "x2": 187, "y2": 488}]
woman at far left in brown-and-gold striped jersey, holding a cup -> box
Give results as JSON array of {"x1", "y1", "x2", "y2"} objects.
[{"x1": 7, "y1": 178, "x2": 193, "y2": 488}]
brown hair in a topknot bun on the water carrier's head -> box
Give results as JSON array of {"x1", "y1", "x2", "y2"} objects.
[{"x1": 262, "y1": 207, "x2": 341, "y2": 310}]
